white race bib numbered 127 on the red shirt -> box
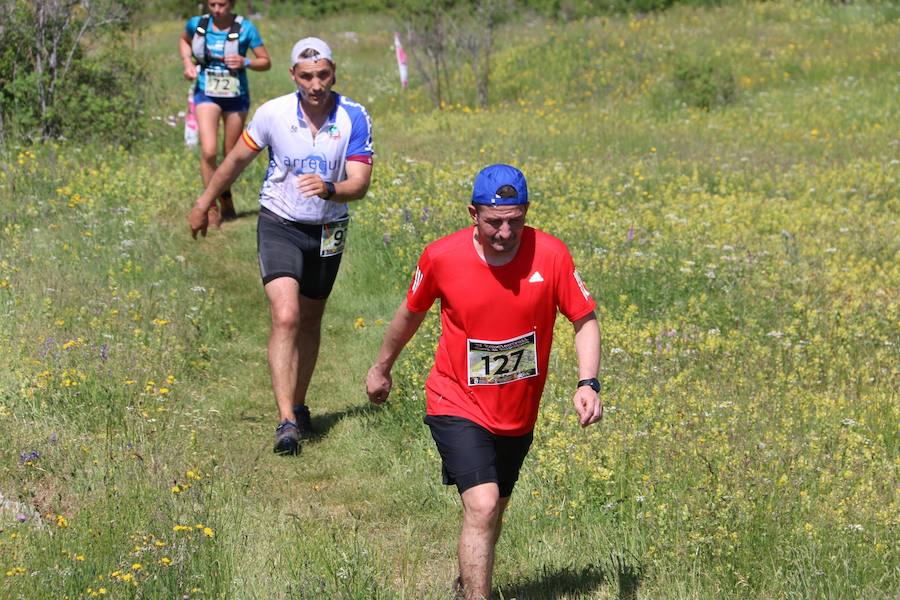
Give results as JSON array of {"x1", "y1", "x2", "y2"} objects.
[{"x1": 466, "y1": 331, "x2": 538, "y2": 385}]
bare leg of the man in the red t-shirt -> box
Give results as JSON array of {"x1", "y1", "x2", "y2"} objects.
[{"x1": 458, "y1": 483, "x2": 509, "y2": 600}]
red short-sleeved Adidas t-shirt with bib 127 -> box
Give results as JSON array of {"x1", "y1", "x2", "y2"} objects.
[{"x1": 406, "y1": 227, "x2": 596, "y2": 435}]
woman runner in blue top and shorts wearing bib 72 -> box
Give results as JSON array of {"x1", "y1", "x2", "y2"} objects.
[{"x1": 178, "y1": 0, "x2": 272, "y2": 227}]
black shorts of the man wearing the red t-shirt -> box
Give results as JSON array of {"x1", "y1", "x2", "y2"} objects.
[{"x1": 425, "y1": 415, "x2": 534, "y2": 498}]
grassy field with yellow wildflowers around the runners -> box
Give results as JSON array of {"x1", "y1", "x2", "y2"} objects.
[{"x1": 0, "y1": 2, "x2": 900, "y2": 599}]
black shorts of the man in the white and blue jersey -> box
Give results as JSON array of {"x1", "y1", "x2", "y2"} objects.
[{"x1": 256, "y1": 207, "x2": 347, "y2": 299}]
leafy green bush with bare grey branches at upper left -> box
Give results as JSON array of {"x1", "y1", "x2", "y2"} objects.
[{"x1": 0, "y1": 0, "x2": 146, "y2": 144}]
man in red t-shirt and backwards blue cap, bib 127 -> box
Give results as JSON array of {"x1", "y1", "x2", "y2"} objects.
[{"x1": 366, "y1": 165, "x2": 603, "y2": 599}]
